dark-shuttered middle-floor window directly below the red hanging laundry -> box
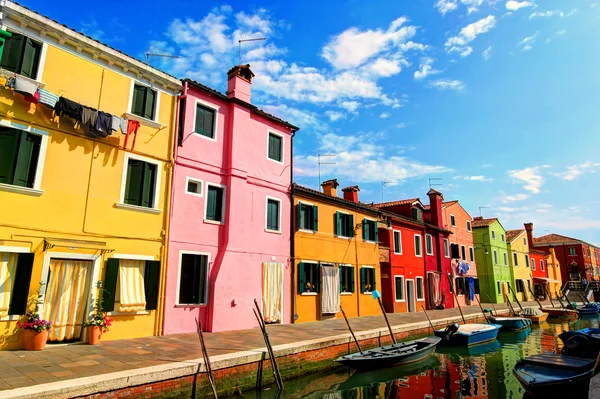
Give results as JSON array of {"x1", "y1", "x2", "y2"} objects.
[{"x1": 123, "y1": 158, "x2": 159, "y2": 208}]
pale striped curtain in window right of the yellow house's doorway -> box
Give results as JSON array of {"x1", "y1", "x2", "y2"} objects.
[{"x1": 119, "y1": 259, "x2": 146, "y2": 312}]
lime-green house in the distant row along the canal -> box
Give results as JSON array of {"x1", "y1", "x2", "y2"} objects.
[{"x1": 472, "y1": 216, "x2": 514, "y2": 303}]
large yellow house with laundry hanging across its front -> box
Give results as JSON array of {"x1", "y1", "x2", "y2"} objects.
[{"x1": 0, "y1": 1, "x2": 181, "y2": 349}]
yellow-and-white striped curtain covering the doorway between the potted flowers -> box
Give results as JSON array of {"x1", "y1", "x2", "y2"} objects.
[{"x1": 42, "y1": 259, "x2": 93, "y2": 342}]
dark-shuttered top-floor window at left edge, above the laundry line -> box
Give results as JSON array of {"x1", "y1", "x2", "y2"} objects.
[{"x1": 0, "y1": 33, "x2": 42, "y2": 79}]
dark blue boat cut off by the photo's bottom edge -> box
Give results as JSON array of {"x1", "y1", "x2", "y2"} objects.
[{"x1": 513, "y1": 353, "x2": 595, "y2": 398}]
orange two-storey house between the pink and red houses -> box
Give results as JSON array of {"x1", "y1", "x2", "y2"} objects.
[{"x1": 293, "y1": 180, "x2": 387, "y2": 322}]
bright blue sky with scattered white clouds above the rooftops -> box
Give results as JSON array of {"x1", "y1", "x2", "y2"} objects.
[{"x1": 22, "y1": 0, "x2": 600, "y2": 244}]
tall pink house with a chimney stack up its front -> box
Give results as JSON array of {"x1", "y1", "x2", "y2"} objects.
[{"x1": 163, "y1": 65, "x2": 298, "y2": 334}]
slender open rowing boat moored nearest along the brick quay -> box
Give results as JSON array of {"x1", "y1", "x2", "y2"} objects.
[{"x1": 336, "y1": 337, "x2": 441, "y2": 370}]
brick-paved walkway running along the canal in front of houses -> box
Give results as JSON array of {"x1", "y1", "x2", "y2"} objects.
[{"x1": 0, "y1": 302, "x2": 548, "y2": 397}]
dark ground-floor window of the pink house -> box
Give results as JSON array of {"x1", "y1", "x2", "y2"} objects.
[{"x1": 177, "y1": 253, "x2": 209, "y2": 305}]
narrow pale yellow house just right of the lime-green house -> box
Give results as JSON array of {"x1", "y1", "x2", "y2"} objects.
[{"x1": 506, "y1": 229, "x2": 533, "y2": 301}]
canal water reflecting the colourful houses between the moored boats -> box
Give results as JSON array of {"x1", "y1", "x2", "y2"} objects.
[{"x1": 244, "y1": 318, "x2": 600, "y2": 399}]
